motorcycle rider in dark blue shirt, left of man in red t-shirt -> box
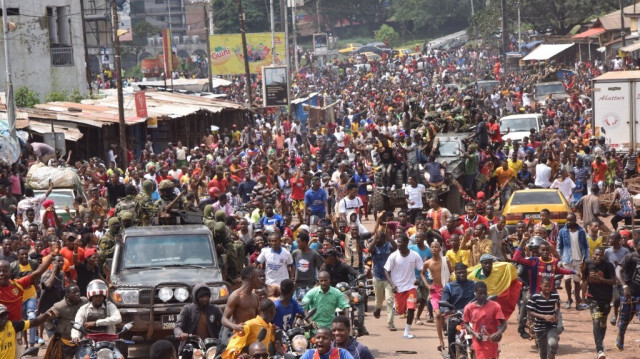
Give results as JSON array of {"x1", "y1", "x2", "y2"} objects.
[{"x1": 440, "y1": 262, "x2": 475, "y2": 358}]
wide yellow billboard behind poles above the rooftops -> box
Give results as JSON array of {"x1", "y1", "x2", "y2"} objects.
[{"x1": 209, "y1": 32, "x2": 286, "y2": 75}]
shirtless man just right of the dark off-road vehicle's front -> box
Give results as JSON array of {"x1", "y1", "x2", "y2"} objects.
[{"x1": 218, "y1": 267, "x2": 262, "y2": 353}]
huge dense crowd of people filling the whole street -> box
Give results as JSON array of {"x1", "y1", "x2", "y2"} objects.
[{"x1": 0, "y1": 39, "x2": 640, "y2": 359}]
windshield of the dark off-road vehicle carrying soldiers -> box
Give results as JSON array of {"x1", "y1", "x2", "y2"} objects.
[{"x1": 121, "y1": 235, "x2": 215, "y2": 269}]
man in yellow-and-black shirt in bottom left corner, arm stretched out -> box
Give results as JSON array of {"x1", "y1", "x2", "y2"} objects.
[{"x1": 0, "y1": 304, "x2": 56, "y2": 359}]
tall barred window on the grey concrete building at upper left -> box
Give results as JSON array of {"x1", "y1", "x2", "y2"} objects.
[{"x1": 47, "y1": 6, "x2": 73, "y2": 67}]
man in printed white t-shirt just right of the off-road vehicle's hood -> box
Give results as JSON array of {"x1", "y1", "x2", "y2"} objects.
[{"x1": 257, "y1": 232, "x2": 293, "y2": 285}]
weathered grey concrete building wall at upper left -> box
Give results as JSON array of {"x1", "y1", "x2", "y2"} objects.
[{"x1": 0, "y1": 0, "x2": 87, "y2": 100}]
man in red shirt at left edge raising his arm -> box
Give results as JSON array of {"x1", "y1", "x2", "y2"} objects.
[{"x1": 0, "y1": 247, "x2": 59, "y2": 320}]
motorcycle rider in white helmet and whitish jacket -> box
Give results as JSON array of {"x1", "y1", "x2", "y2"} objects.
[{"x1": 71, "y1": 279, "x2": 123, "y2": 358}]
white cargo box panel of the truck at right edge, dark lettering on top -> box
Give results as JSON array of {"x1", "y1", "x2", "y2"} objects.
[{"x1": 593, "y1": 81, "x2": 631, "y2": 148}]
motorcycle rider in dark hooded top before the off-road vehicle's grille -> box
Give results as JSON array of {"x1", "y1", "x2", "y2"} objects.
[{"x1": 173, "y1": 283, "x2": 222, "y2": 353}]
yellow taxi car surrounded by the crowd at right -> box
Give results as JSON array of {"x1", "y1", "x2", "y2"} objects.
[{"x1": 502, "y1": 189, "x2": 573, "y2": 233}]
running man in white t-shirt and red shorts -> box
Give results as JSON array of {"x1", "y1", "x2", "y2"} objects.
[{"x1": 384, "y1": 235, "x2": 423, "y2": 339}]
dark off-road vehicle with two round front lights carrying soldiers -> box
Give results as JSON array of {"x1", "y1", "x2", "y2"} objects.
[{"x1": 109, "y1": 224, "x2": 230, "y2": 341}]
